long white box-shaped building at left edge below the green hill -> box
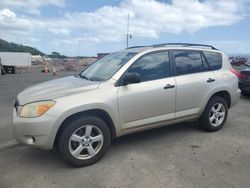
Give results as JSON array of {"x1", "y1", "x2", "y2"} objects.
[{"x1": 0, "y1": 52, "x2": 31, "y2": 67}]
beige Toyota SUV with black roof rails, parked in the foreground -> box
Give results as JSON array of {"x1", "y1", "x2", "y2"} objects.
[{"x1": 13, "y1": 43, "x2": 240, "y2": 167}]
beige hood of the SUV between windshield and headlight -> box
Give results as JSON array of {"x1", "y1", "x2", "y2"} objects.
[{"x1": 17, "y1": 76, "x2": 100, "y2": 105}]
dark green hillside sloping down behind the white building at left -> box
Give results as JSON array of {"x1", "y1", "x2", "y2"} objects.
[{"x1": 0, "y1": 39, "x2": 45, "y2": 55}]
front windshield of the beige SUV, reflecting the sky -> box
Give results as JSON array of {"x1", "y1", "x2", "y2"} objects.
[{"x1": 80, "y1": 52, "x2": 136, "y2": 81}]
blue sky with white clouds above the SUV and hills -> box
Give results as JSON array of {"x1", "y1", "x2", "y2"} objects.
[{"x1": 0, "y1": 0, "x2": 250, "y2": 56}]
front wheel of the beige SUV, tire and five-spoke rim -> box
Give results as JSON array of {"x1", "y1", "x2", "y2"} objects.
[{"x1": 58, "y1": 116, "x2": 111, "y2": 167}]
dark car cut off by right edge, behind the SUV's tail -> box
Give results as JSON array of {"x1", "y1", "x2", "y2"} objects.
[{"x1": 239, "y1": 68, "x2": 250, "y2": 95}]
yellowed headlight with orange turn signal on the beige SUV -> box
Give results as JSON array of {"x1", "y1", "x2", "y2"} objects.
[{"x1": 20, "y1": 101, "x2": 55, "y2": 118}]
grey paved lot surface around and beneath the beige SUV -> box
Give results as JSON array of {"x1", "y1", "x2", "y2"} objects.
[{"x1": 0, "y1": 68, "x2": 250, "y2": 188}]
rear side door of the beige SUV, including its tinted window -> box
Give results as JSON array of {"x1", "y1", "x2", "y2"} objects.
[{"x1": 172, "y1": 50, "x2": 216, "y2": 118}]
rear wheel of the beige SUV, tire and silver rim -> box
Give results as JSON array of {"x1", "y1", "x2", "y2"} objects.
[{"x1": 199, "y1": 96, "x2": 228, "y2": 132}]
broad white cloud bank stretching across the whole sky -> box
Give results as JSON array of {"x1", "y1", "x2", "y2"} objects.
[{"x1": 0, "y1": 0, "x2": 247, "y2": 54}]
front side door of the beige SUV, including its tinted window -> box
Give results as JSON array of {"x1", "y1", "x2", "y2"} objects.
[{"x1": 118, "y1": 51, "x2": 176, "y2": 130}]
